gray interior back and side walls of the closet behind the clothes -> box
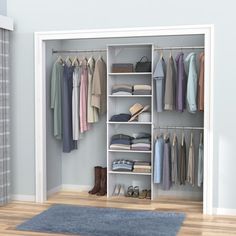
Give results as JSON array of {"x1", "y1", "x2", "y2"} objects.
[{"x1": 46, "y1": 35, "x2": 204, "y2": 198}]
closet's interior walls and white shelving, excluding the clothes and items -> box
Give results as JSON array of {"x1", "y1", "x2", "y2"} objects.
[{"x1": 43, "y1": 35, "x2": 204, "y2": 203}]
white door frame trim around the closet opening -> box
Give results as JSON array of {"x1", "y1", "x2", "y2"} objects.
[{"x1": 35, "y1": 25, "x2": 214, "y2": 215}]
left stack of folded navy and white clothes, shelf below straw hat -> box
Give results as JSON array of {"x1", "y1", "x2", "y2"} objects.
[{"x1": 110, "y1": 134, "x2": 132, "y2": 150}]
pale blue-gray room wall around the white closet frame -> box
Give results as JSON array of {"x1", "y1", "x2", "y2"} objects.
[{"x1": 7, "y1": 0, "x2": 236, "y2": 209}]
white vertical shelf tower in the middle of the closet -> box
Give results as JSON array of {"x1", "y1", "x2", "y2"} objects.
[{"x1": 107, "y1": 43, "x2": 153, "y2": 199}]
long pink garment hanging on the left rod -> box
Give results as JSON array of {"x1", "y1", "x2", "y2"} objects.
[{"x1": 79, "y1": 59, "x2": 90, "y2": 133}]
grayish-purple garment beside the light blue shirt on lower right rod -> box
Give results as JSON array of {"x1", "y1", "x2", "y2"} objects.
[{"x1": 162, "y1": 138, "x2": 171, "y2": 190}]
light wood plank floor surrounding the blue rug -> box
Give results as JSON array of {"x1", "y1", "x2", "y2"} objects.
[{"x1": 0, "y1": 192, "x2": 236, "y2": 236}]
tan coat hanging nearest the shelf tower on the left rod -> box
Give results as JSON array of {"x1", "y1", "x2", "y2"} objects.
[{"x1": 91, "y1": 57, "x2": 107, "y2": 115}]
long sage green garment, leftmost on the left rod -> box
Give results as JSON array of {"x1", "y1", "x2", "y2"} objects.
[{"x1": 51, "y1": 60, "x2": 64, "y2": 139}]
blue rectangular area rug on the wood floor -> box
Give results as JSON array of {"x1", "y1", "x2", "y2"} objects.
[{"x1": 16, "y1": 205, "x2": 185, "y2": 236}]
